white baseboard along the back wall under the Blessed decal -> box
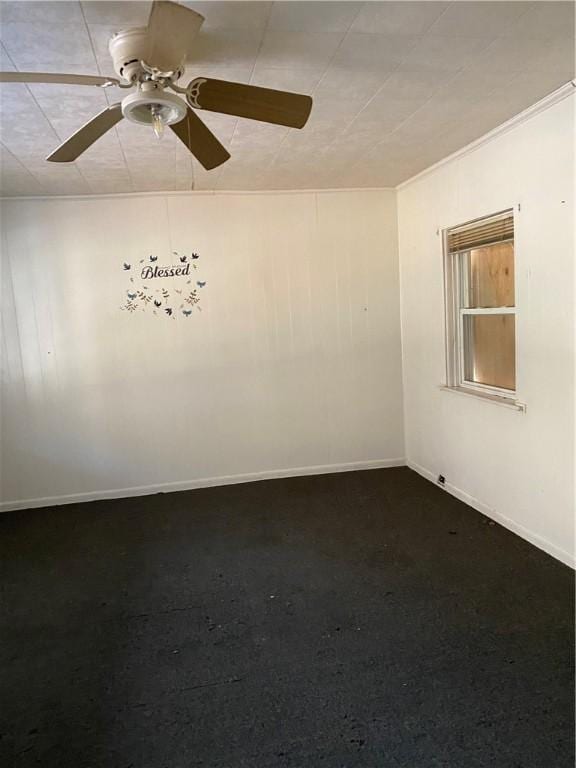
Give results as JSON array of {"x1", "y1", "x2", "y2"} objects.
[{"x1": 0, "y1": 458, "x2": 406, "y2": 512}]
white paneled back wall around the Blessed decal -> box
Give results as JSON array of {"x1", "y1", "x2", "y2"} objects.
[{"x1": 1, "y1": 191, "x2": 404, "y2": 508}]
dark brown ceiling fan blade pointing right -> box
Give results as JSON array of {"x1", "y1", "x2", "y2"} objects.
[{"x1": 186, "y1": 77, "x2": 312, "y2": 128}]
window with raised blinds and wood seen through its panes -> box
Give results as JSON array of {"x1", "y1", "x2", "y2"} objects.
[{"x1": 445, "y1": 211, "x2": 516, "y2": 399}]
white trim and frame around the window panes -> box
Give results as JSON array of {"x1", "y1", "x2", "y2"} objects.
[{"x1": 440, "y1": 212, "x2": 526, "y2": 411}]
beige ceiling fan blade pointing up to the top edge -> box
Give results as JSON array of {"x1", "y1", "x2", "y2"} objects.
[{"x1": 145, "y1": 0, "x2": 204, "y2": 72}]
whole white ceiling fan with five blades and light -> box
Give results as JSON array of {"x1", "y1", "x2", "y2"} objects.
[{"x1": 0, "y1": 0, "x2": 312, "y2": 170}]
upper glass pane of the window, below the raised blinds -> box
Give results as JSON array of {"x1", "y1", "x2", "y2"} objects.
[{"x1": 462, "y1": 243, "x2": 514, "y2": 308}]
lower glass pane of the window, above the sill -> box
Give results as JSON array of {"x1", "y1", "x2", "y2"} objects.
[{"x1": 463, "y1": 315, "x2": 516, "y2": 390}]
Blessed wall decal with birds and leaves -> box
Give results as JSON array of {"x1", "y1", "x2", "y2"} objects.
[{"x1": 120, "y1": 251, "x2": 206, "y2": 320}]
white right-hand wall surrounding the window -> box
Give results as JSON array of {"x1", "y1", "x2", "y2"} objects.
[{"x1": 398, "y1": 97, "x2": 575, "y2": 562}]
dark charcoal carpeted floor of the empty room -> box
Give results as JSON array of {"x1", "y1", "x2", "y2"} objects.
[{"x1": 0, "y1": 468, "x2": 574, "y2": 768}]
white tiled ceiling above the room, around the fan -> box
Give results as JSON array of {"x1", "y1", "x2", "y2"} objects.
[{"x1": 0, "y1": 0, "x2": 574, "y2": 196}]
